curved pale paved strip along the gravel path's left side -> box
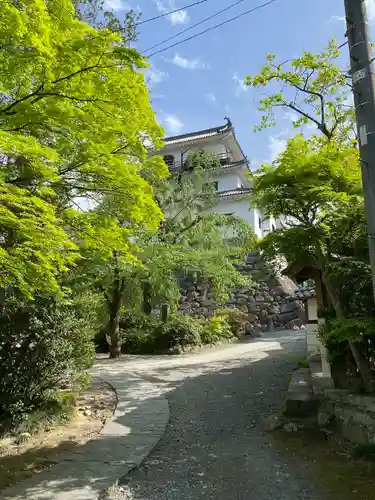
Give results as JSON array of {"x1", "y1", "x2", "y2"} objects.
[{"x1": 0, "y1": 364, "x2": 169, "y2": 500}]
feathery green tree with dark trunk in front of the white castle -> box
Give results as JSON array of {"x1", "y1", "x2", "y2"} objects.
[{"x1": 75, "y1": 152, "x2": 256, "y2": 357}]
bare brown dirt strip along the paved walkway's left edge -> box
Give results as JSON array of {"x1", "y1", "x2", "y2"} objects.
[{"x1": 0, "y1": 380, "x2": 117, "y2": 490}]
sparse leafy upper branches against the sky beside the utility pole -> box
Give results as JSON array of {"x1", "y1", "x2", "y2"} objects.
[{"x1": 245, "y1": 40, "x2": 356, "y2": 142}]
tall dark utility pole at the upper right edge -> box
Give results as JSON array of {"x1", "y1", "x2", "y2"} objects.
[{"x1": 344, "y1": 0, "x2": 375, "y2": 297}]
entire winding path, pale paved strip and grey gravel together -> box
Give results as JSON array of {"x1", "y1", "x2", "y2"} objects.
[{"x1": 0, "y1": 337, "x2": 312, "y2": 500}]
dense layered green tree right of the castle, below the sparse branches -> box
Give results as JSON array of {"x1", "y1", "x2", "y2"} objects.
[{"x1": 252, "y1": 135, "x2": 373, "y2": 391}]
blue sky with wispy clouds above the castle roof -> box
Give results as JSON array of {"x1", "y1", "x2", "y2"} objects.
[{"x1": 106, "y1": 0, "x2": 375, "y2": 165}]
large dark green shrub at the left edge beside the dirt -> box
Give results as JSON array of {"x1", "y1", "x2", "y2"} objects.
[{"x1": 0, "y1": 297, "x2": 95, "y2": 430}]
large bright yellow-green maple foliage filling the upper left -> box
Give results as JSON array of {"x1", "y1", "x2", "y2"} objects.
[{"x1": 0, "y1": 0, "x2": 167, "y2": 296}]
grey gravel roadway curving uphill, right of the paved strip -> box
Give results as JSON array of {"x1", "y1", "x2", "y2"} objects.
[{"x1": 110, "y1": 336, "x2": 323, "y2": 500}]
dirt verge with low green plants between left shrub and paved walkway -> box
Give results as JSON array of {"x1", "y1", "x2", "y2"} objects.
[{"x1": 0, "y1": 380, "x2": 116, "y2": 492}]
